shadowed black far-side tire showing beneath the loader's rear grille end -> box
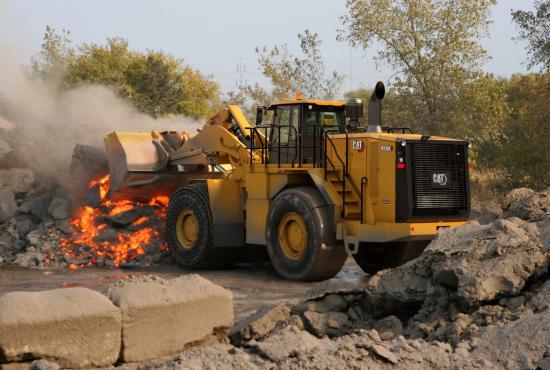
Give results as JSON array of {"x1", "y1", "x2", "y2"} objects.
[{"x1": 352, "y1": 240, "x2": 430, "y2": 275}]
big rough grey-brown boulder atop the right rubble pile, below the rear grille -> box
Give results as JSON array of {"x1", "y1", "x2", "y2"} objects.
[{"x1": 434, "y1": 218, "x2": 546, "y2": 305}]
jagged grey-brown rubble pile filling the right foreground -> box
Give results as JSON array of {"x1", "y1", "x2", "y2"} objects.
[{"x1": 141, "y1": 189, "x2": 550, "y2": 369}]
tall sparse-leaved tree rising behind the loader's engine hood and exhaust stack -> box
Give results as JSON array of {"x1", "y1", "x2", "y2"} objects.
[{"x1": 339, "y1": 0, "x2": 496, "y2": 134}]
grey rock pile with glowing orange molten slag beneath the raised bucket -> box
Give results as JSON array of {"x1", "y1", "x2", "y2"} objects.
[{"x1": 0, "y1": 144, "x2": 169, "y2": 269}]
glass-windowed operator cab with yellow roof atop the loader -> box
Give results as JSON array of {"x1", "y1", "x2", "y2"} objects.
[{"x1": 257, "y1": 99, "x2": 346, "y2": 164}]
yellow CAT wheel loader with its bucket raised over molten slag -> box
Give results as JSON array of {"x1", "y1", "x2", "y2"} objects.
[{"x1": 105, "y1": 82, "x2": 470, "y2": 281}]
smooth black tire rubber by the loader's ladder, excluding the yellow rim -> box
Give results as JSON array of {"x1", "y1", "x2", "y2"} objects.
[{"x1": 266, "y1": 187, "x2": 347, "y2": 281}]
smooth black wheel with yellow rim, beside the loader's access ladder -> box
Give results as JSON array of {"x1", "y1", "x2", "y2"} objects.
[{"x1": 266, "y1": 187, "x2": 347, "y2": 281}]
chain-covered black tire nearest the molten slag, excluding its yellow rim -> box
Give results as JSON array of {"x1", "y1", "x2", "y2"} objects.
[{"x1": 166, "y1": 183, "x2": 238, "y2": 270}]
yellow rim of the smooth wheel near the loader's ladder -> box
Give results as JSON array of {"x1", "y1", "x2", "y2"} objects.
[{"x1": 279, "y1": 212, "x2": 308, "y2": 261}]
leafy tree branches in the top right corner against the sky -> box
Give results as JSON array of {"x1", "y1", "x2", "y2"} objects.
[{"x1": 512, "y1": 0, "x2": 550, "y2": 72}]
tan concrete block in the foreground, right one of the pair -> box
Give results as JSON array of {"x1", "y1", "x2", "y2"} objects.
[{"x1": 107, "y1": 275, "x2": 233, "y2": 362}]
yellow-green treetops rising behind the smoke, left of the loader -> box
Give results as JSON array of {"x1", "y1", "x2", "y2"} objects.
[{"x1": 31, "y1": 27, "x2": 220, "y2": 118}]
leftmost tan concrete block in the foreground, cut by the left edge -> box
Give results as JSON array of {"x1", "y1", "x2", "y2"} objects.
[{"x1": 0, "y1": 288, "x2": 122, "y2": 368}]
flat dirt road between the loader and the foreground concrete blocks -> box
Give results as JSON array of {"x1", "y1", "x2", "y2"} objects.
[{"x1": 0, "y1": 259, "x2": 365, "y2": 320}]
